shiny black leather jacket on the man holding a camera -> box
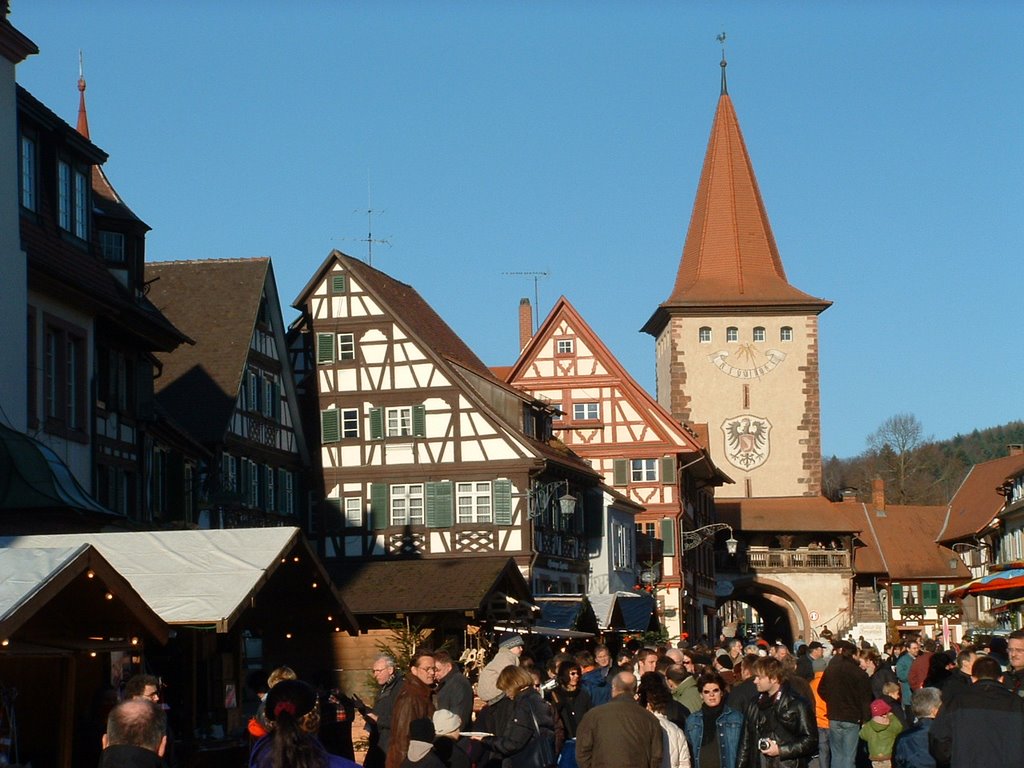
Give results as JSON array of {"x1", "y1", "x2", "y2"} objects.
[{"x1": 736, "y1": 683, "x2": 818, "y2": 768}]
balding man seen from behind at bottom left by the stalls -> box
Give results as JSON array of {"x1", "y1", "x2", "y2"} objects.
[{"x1": 99, "y1": 698, "x2": 167, "y2": 768}]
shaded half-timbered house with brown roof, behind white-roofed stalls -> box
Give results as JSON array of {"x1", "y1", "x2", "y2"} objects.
[{"x1": 145, "y1": 258, "x2": 309, "y2": 528}]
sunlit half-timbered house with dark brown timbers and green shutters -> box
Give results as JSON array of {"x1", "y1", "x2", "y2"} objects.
[{"x1": 292, "y1": 251, "x2": 601, "y2": 606}]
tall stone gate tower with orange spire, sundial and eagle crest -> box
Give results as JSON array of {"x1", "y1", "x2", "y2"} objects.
[{"x1": 643, "y1": 63, "x2": 830, "y2": 498}]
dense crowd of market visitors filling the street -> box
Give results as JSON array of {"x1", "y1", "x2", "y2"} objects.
[{"x1": 88, "y1": 630, "x2": 1024, "y2": 768}]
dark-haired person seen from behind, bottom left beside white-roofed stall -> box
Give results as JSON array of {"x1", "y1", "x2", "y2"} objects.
[{"x1": 249, "y1": 680, "x2": 356, "y2": 768}]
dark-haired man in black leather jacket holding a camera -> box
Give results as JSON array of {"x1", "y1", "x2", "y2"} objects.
[{"x1": 736, "y1": 657, "x2": 818, "y2": 768}]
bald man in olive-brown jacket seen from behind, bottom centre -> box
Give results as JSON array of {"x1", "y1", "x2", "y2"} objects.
[{"x1": 577, "y1": 672, "x2": 663, "y2": 768}]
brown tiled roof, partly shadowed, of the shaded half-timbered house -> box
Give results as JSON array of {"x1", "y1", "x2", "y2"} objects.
[{"x1": 145, "y1": 257, "x2": 270, "y2": 444}]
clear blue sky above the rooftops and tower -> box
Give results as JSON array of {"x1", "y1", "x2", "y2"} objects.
[{"x1": 11, "y1": 0, "x2": 1024, "y2": 457}]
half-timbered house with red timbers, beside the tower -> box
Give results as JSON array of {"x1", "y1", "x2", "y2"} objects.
[{"x1": 506, "y1": 296, "x2": 729, "y2": 637}]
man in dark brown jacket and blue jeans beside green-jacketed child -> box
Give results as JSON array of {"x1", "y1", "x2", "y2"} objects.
[{"x1": 818, "y1": 640, "x2": 871, "y2": 768}]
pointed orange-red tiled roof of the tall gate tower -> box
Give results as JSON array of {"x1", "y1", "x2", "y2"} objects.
[{"x1": 643, "y1": 92, "x2": 830, "y2": 334}]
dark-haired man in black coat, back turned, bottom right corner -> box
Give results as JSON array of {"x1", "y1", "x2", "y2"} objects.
[{"x1": 928, "y1": 656, "x2": 1024, "y2": 768}]
